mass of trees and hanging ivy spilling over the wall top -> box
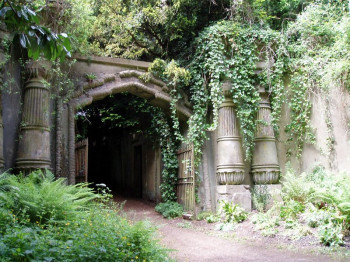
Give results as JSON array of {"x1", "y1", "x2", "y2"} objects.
[{"x1": 1, "y1": 0, "x2": 350, "y2": 203}]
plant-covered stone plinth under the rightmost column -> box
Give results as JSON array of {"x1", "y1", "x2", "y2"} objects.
[{"x1": 252, "y1": 184, "x2": 283, "y2": 210}]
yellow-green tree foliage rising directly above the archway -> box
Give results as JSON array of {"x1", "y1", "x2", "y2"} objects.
[{"x1": 93, "y1": 0, "x2": 228, "y2": 60}]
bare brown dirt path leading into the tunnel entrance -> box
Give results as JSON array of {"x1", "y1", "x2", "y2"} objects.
[{"x1": 116, "y1": 198, "x2": 348, "y2": 262}]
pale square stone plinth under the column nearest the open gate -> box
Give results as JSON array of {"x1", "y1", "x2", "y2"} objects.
[{"x1": 216, "y1": 185, "x2": 252, "y2": 212}]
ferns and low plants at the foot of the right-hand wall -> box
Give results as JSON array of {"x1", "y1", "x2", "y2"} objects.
[{"x1": 252, "y1": 167, "x2": 350, "y2": 246}]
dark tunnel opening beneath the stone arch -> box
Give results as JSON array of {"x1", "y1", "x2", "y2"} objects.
[{"x1": 75, "y1": 93, "x2": 161, "y2": 202}]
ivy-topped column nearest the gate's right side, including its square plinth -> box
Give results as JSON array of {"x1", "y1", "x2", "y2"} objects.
[{"x1": 216, "y1": 81, "x2": 251, "y2": 211}]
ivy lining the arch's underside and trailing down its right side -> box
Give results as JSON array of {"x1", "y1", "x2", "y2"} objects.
[{"x1": 76, "y1": 93, "x2": 178, "y2": 202}]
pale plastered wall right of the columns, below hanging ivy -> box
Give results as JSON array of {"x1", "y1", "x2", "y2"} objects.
[{"x1": 277, "y1": 84, "x2": 350, "y2": 174}]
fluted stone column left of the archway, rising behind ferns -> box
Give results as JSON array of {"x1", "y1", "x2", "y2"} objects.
[{"x1": 16, "y1": 62, "x2": 51, "y2": 171}]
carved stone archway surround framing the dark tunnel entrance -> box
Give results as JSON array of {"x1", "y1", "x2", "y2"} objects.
[{"x1": 60, "y1": 57, "x2": 192, "y2": 184}]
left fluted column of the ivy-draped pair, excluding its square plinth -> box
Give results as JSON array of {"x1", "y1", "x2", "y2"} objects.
[{"x1": 216, "y1": 81, "x2": 244, "y2": 185}]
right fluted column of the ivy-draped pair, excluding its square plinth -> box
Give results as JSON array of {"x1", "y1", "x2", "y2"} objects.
[{"x1": 252, "y1": 88, "x2": 280, "y2": 184}]
